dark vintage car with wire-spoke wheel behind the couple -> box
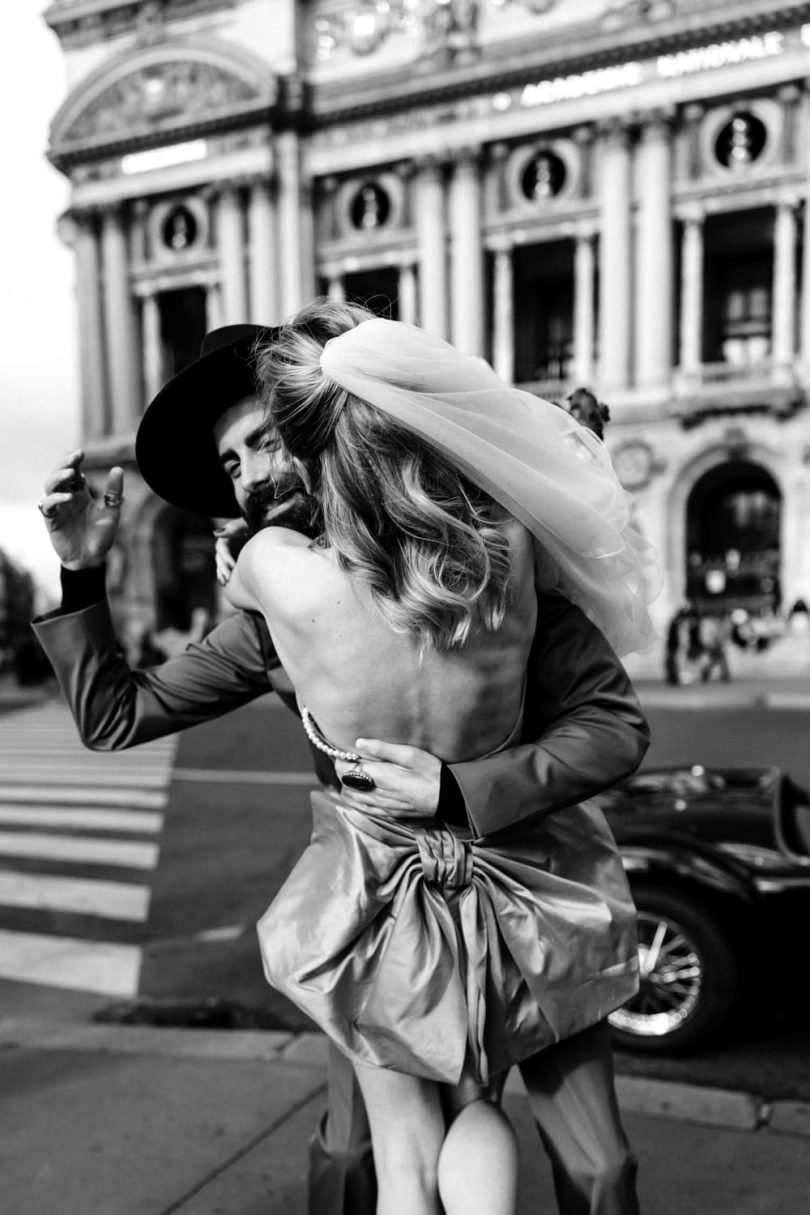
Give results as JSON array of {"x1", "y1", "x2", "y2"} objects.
[{"x1": 597, "y1": 764, "x2": 810, "y2": 1053}]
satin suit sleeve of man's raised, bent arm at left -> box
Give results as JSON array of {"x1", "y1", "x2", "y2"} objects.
[{"x1": 33, "y1": 600, "x2": 281, "y2": 751}]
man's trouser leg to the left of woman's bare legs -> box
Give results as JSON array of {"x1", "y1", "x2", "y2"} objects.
[{"x1": 308, "y1": 1045, "x2": 376, "y2": 1215}]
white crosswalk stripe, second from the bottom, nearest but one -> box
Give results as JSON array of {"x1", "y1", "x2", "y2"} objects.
[{"x1": 0, "y1": 870, "x2": 149, "y2": 923}]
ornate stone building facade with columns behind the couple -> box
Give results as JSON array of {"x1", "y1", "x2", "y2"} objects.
[{"x1": 46, "y1": 0, "x2": 810, "y2": 660}]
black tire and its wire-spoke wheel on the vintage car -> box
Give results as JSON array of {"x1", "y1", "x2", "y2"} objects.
[{"x1": 608, "y1": 887, "x2": 740, "y2": 1055}]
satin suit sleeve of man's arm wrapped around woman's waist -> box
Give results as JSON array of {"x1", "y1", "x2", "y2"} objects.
[{"x1": 449, "y1": 595, "x2": 650, "y2": 837}]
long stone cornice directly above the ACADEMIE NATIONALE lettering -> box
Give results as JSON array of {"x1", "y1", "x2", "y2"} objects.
[{"x1": 307, "y1": 0, "x2": 810, "y2": 126}]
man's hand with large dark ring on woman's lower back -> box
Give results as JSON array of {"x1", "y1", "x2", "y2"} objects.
[{"x1": 335, "y1": 739, "x2": 442, "y2": 819}]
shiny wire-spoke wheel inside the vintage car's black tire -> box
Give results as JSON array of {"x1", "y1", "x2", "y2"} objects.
[{"x1": 611, "y1": 911, "x2": 703, "y2": 1038}]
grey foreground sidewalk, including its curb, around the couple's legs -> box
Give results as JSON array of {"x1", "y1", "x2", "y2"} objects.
[{"x1": 0, "y1": 1021, "x2": 810, "y2": 1215}]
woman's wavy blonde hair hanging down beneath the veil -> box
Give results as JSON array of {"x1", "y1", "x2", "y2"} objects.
[{"x1": 255, "y1": 300, "x2": 511, "y2": 650}]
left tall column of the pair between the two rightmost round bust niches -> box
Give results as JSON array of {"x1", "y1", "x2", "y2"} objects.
[{"x1": 599, "y1": 122, "x2": 631, "y2": 392}]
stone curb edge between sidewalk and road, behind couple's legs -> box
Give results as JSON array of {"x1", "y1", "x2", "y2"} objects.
[{"x1": 0, "y1": 1017, "x2": 810, "y2": 1138}]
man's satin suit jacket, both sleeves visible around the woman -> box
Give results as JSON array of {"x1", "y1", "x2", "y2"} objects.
[{"x1": 33, "y1": 595, "x2": 648, "y2": 837}]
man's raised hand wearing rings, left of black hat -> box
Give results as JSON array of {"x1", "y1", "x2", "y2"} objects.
[{"x1": 39, "y1": 451, "x2": 124, "y2": 570}]
